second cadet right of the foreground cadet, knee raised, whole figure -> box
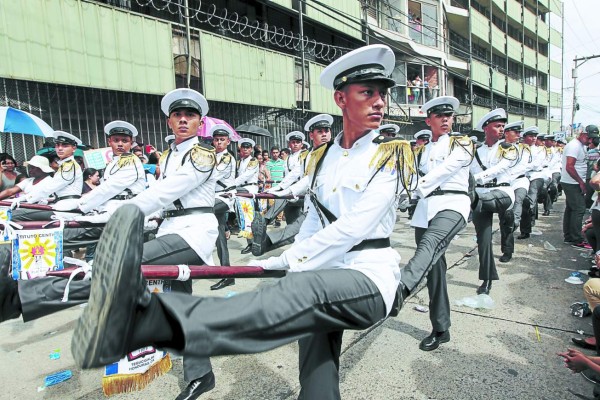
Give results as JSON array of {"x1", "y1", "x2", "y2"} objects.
[{"x1": 471, "y1": 108, "x2": 517, "y2": 294}]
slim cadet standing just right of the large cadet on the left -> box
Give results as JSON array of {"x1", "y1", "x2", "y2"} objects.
[{"x1": 209, "y1": 124, "x2": 235, "y2": 290}]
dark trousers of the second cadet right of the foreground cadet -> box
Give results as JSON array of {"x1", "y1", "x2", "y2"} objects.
[{"x1": 473, "y1": 189, "x2": 511, "y2": 281}]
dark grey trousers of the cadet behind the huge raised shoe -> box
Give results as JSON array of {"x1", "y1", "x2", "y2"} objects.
[{"x1": 19, "y1": 234, "x2": 212, "y2": 381}]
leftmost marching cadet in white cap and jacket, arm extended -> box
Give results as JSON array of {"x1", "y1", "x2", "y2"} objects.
[{"x1": 12, "y1": 131, "x2": 83, "y2": 221}]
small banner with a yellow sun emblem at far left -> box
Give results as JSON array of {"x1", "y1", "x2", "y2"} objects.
[{"x1": 12, "y1": 228, "x2": 63, "y2": 280}]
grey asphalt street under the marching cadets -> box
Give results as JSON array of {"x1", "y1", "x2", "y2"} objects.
[{"x1": 0, "y1": 197, "x2": 593, "y2": 400}]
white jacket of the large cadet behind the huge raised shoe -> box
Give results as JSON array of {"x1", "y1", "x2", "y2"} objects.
[{"x1": 124, "y1": 137, "x2": 219, "y2": 265}]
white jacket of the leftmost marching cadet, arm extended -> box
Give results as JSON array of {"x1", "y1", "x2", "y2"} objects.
[{"x1": 25, "y1": 156, "x2": 83, "y2": 211}]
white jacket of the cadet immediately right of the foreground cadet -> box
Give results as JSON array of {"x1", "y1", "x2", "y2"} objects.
[{"x1": 411, "y1": 134, "x2": 473, "y2": 228}]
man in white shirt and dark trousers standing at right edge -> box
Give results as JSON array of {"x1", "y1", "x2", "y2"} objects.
[{"x1": 560, "y1": 125, "x2": 600, "y2": 248}]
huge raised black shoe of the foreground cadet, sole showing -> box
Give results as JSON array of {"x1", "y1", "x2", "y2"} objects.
[{"x1": 71, "y1": 205, "x2": 152, "y2": 369}]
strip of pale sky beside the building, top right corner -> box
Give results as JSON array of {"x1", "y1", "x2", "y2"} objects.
[{"x1": 564, "y1": 0, "x2": 600, "y2": 125}]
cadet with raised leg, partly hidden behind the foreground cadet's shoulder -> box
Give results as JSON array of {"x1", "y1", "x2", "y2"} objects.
[{"x1": 252, "y1": 114, "x2": 332, "y2": 256}]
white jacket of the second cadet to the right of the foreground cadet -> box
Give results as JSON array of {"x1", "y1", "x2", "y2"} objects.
[{"x1": 471, "y1": 141, "x2": 517, "y2": 207}]
